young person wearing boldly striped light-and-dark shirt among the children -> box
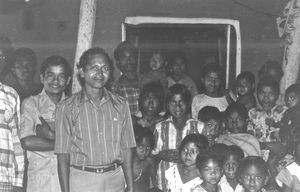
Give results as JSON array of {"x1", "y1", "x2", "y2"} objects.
[{"x1": 153, "y1": 84, "x2": 204, "y2": 191}]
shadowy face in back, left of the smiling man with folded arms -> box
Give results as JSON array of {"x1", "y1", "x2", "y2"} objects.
[{"x1": 12, "y1": 57, "x2": 35, "y2": 81}]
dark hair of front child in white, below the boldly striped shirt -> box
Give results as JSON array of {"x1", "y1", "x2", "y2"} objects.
[{"x1": 178, "y1": 134, "x2": 208, "y2": 152}]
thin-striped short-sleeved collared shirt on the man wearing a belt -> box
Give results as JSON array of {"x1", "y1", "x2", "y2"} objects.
[{"x1": 54, "y1": 90, "x2": 136, "y2": 166}]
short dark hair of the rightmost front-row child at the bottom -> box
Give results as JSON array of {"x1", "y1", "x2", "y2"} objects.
[{"x1": 237, "y1": 156, "x2": 269, "y2": 176}]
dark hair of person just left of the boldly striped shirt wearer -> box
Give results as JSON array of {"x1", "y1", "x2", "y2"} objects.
[{"x1": 139, "y1": 82, "x2": 165, "y2": 112}]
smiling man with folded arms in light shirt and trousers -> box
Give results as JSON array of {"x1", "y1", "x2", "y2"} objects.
[{"x1": 20, "y1": 56, "x2": 71, "y2": 192}]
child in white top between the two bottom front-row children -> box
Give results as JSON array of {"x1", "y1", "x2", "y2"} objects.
[{"x1": 219, "y1": 145, "x2": 244, "y2": 192}]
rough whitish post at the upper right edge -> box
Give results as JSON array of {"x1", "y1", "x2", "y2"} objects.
[{"x1": 277, "y1": 0, "x2": 300, "y2": 102}]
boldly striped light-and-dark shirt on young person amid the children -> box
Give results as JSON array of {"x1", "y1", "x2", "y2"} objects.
[{"x1": 152, "y1": 117, "x2": 204, "y2": 191}]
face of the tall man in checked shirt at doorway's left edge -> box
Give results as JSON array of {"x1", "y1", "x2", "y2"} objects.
[{"x1": 117, "y1": 50, "x2": 137, "y2": 72}]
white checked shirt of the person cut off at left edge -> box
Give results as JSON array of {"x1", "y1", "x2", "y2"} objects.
[{"x1": 0, "y1": 83, "x2": 24, "y2": 187}]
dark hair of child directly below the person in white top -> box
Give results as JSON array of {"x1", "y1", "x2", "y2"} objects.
[{"x1": 198, "y1": 106, "x2": 222, "y2": 122}]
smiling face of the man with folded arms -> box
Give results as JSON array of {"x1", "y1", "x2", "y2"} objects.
[{"x1": 40, "y1": 65, "x2": 70, "y2": 94}]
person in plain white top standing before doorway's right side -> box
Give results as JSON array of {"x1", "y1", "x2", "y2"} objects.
[{"x1": 192, "y1": 64, "x2": 232, "y2": 119}]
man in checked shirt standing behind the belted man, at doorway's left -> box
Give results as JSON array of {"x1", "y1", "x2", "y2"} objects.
[{"x1": 111, "y1": 41, "x2": 141, "y2": 115}]
